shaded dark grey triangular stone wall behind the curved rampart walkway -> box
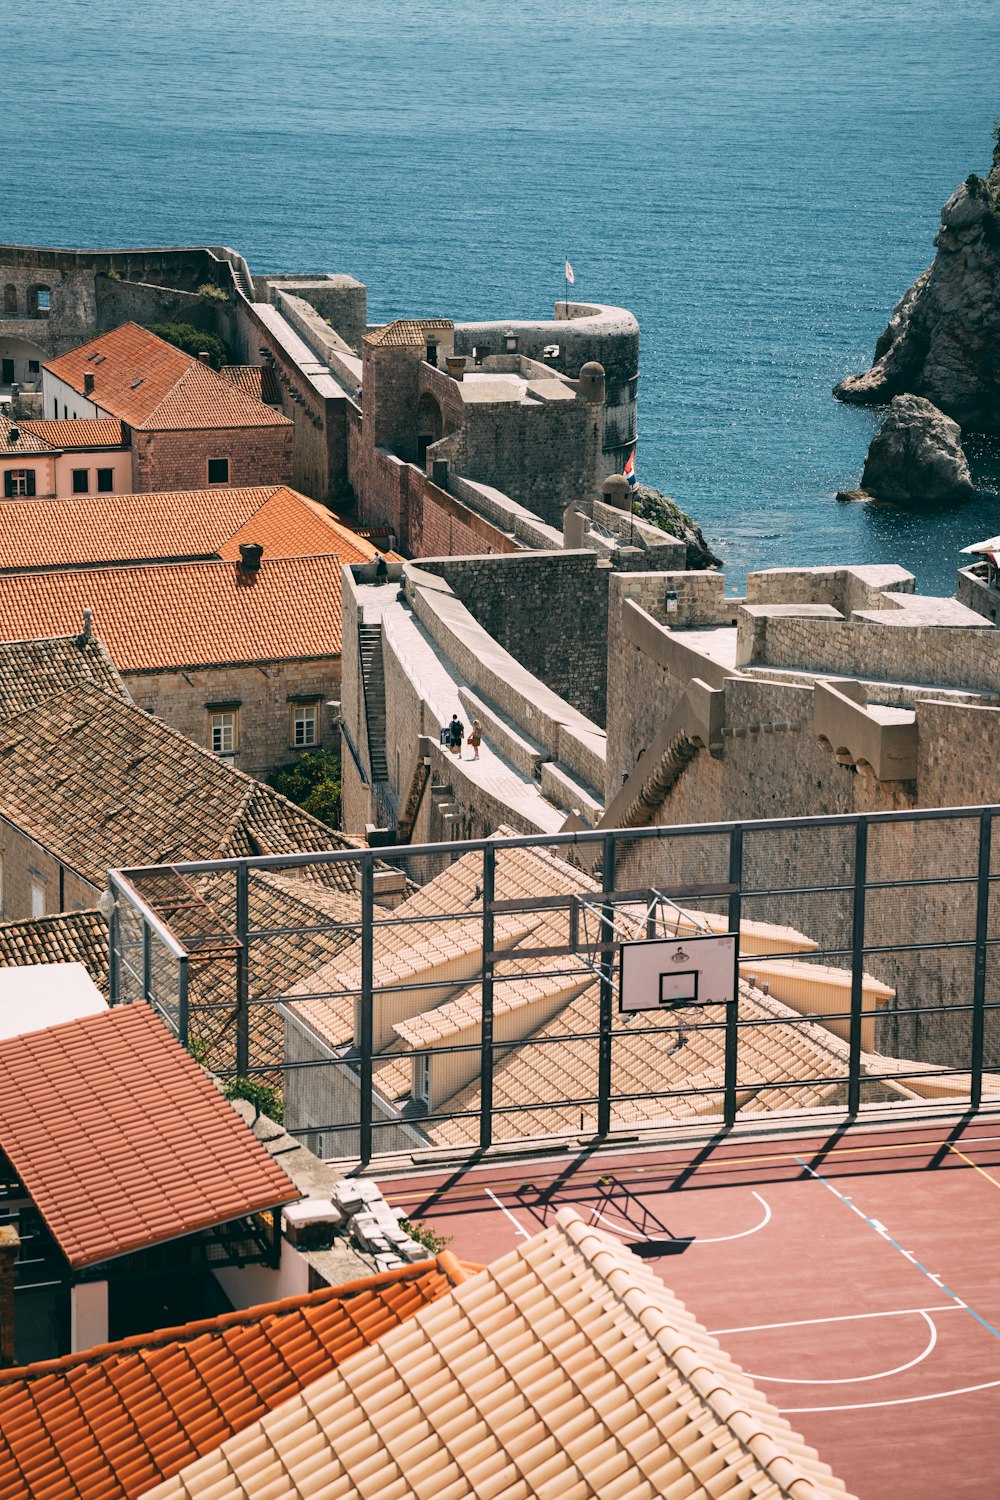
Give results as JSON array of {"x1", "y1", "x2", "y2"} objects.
[{"x1": 420, "y1": 552, "x2": 610, "y2": 725}]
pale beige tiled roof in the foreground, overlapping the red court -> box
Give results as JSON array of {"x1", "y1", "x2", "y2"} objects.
[{"x1": 148, "y1": 1209, "x2": 863, "y2": 1500}]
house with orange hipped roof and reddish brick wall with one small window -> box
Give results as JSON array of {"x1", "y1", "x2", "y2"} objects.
[{"x1": 42, "y1": 323, "x2": 292, "y2": 494}]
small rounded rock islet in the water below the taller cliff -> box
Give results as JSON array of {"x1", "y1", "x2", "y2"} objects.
[{"x1": 861, "y1": 396, "x2": 972, "y2": 506}]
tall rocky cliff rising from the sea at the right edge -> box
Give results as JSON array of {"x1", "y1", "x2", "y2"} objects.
[{"x1": 834, "y1": 129, "x2": 1000, "y2": 432}]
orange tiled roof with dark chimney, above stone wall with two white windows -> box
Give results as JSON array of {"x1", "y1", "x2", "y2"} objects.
[{"x1": 0, "y1": 552, "x2": 340, "y2": 672}]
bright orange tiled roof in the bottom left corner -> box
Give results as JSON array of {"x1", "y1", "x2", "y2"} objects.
[{"x1": 0, "y1": 1253, "x2": 478, "y2": 1500}]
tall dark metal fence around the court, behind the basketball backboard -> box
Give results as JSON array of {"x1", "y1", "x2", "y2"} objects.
[{"x1": 109, "y1": 807, "x2": 1000, "y2": 1163}]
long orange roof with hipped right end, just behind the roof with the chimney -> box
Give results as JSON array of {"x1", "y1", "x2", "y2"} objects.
[{"x1": 0, "y1": 485, "x2": 375, "y2": 573}]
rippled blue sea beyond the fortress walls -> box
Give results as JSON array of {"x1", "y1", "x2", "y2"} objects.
[{"x1": 0, "y1": 0, "x2": 1000, "y2": 591}]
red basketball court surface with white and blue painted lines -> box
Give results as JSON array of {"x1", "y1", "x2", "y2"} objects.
[{"x1": 381, "y1": 1118, "x2": 1000, "y2": 1500}]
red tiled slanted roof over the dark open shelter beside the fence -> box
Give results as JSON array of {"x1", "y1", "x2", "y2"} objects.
[{"x1": 0, "y1": 1004, "x2": 300, "y2": 1268}]
